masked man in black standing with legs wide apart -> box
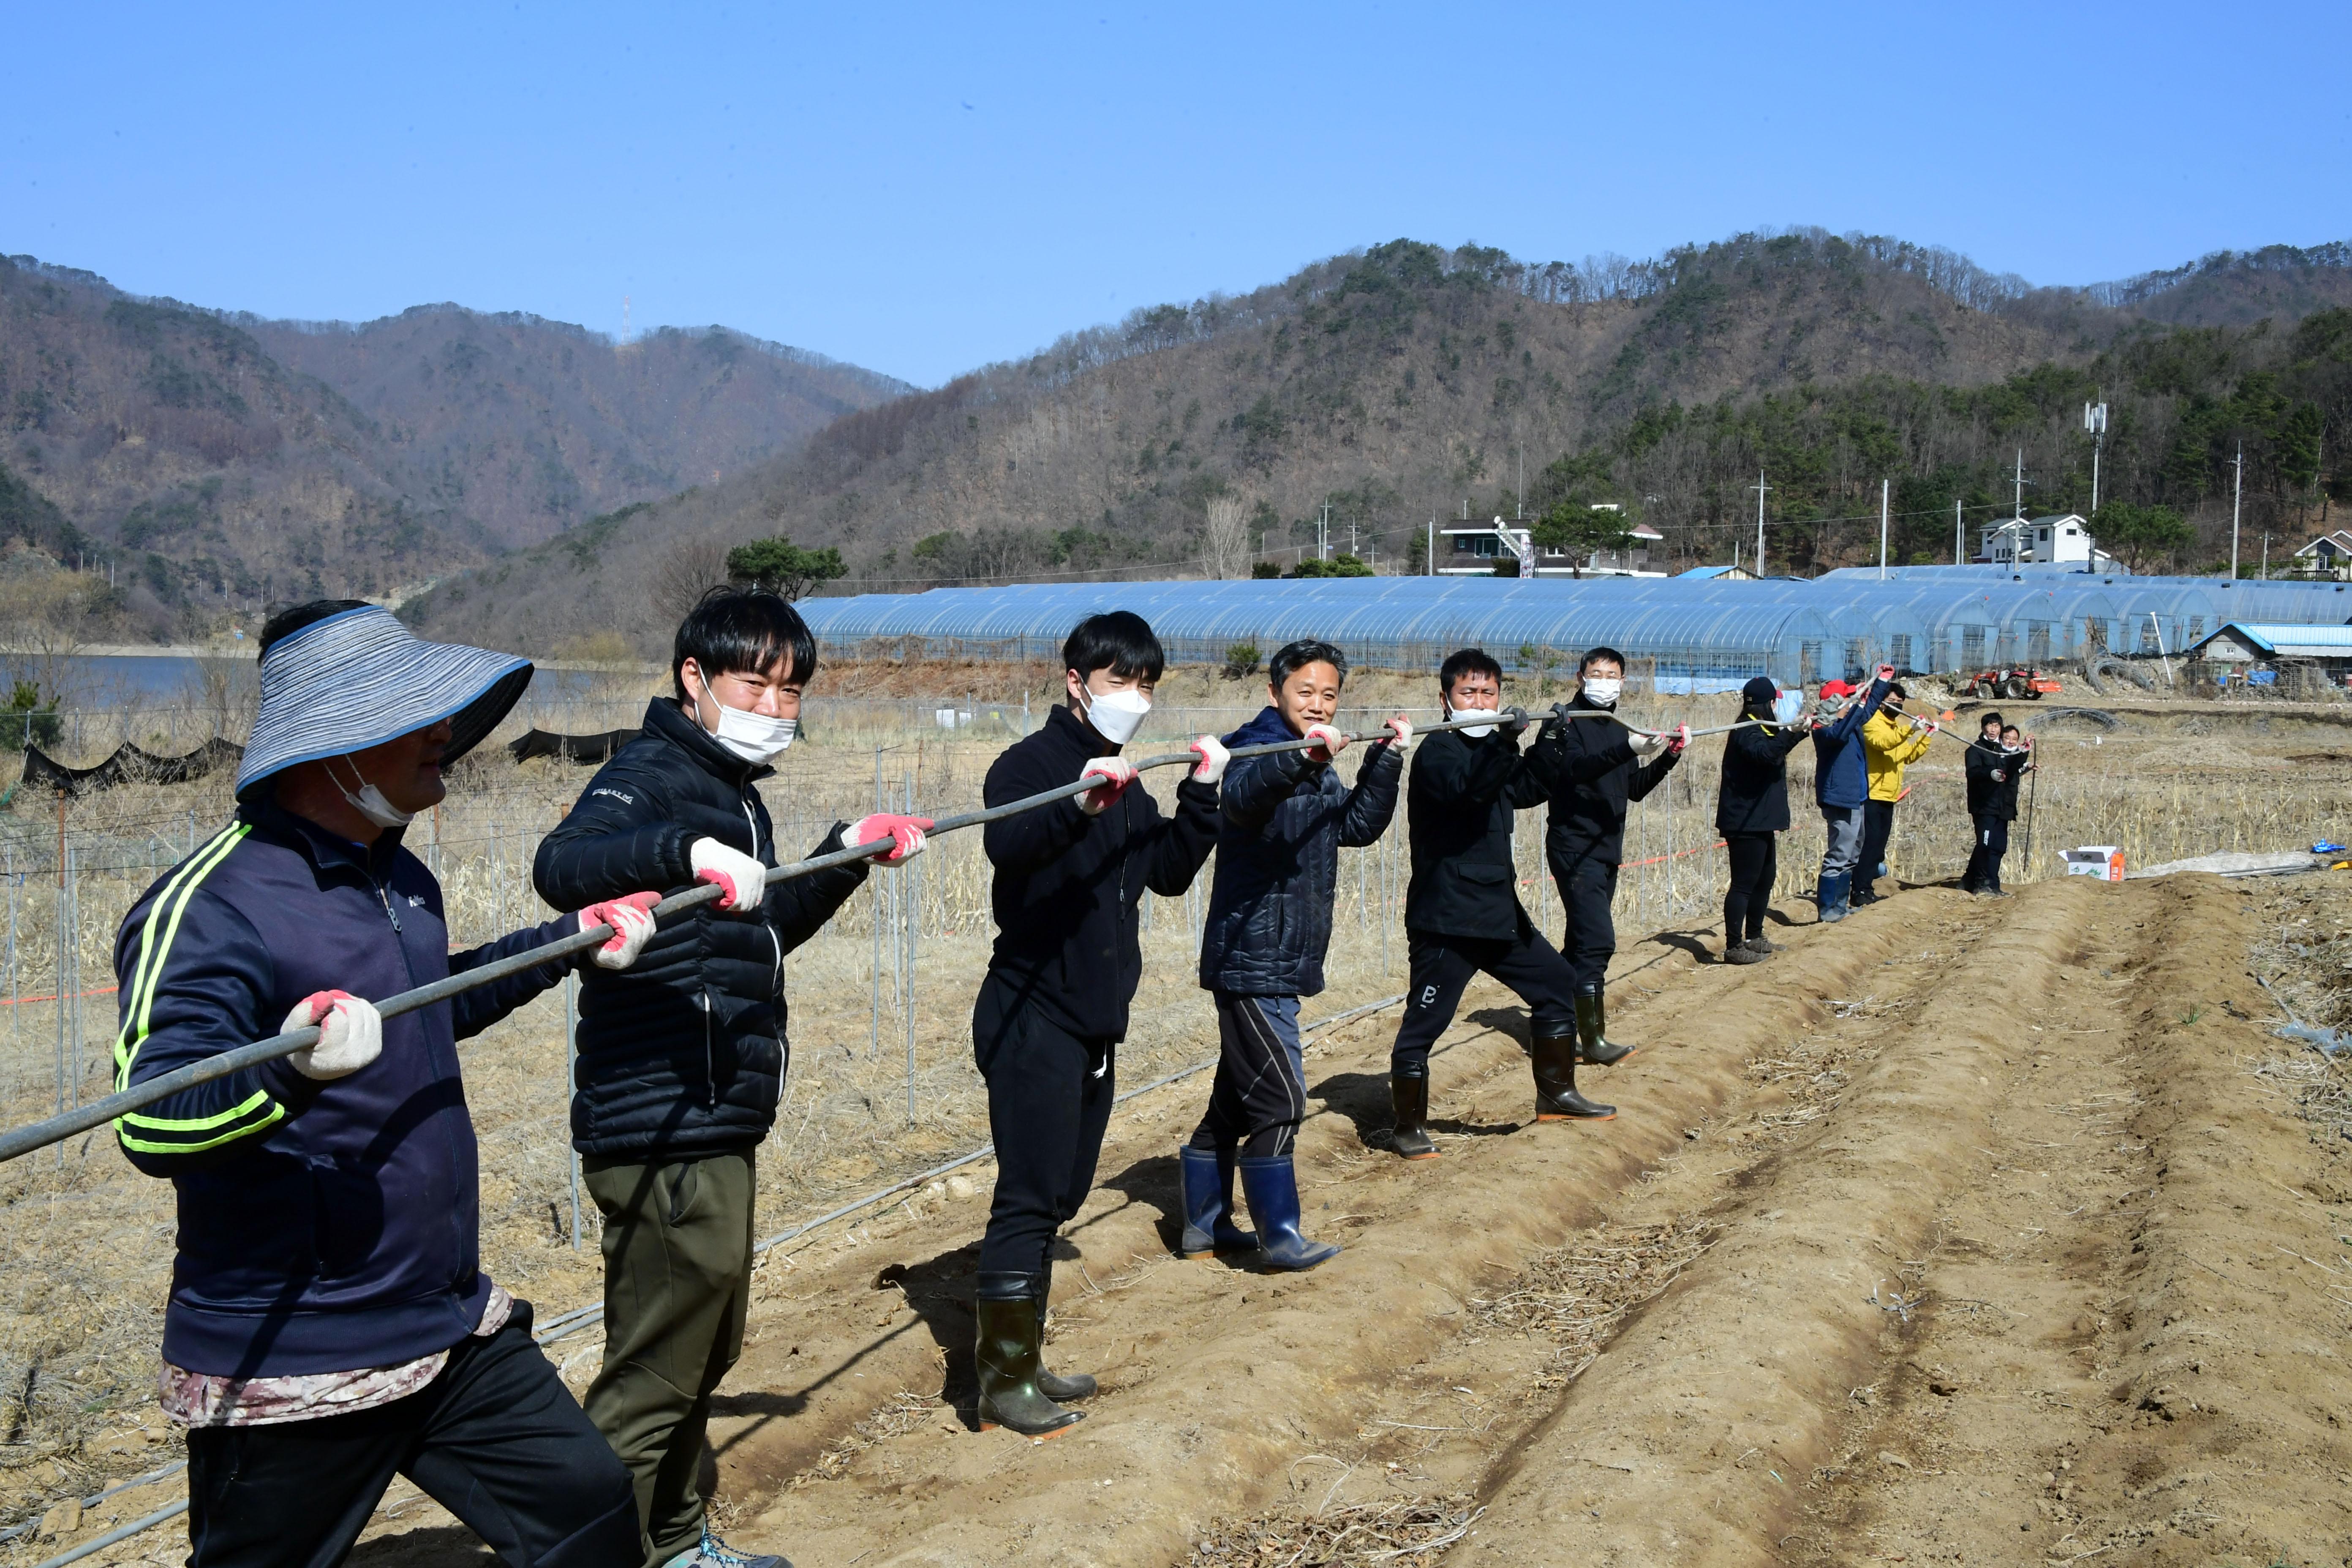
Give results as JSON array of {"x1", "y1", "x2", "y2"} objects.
[{"x1": 1388, "y1": 649, "x2": 1632, "y2": 1159}]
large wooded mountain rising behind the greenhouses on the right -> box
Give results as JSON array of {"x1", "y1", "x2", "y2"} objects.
[{"x1": 405, "y1": 230, "x2": 2352, "y2": 651}]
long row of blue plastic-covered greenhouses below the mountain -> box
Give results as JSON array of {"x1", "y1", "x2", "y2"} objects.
[{"x1": 802, "y1": 566, "x2": 2352, "y2": 691}]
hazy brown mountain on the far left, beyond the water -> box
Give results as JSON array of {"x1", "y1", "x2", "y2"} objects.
[{"x1": 0, "y1": 256, "x2": 908, "y2": 635}]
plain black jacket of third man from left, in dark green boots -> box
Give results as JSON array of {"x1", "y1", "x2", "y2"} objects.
[{"x1": 981, "y1": 708, "x2": 1216, "y2": 1041}]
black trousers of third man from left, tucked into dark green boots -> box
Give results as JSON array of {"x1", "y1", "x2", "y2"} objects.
[{"x1": 972, "y1": 971, "x2": 1117, "y2": 1274}]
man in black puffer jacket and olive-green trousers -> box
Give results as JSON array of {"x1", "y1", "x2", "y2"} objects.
[{"x1": 531, "y1": 588, "x2": 931, "y2": 1568}]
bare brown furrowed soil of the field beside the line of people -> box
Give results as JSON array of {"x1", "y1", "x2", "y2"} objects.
[{"x1": 343, "y1": 877, "x2": 2352, "y2": 1568}]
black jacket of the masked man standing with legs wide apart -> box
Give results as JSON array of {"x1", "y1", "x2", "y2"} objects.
[{"x1": 1404, "y1": 729, "x2": 1550, "y2": 940}]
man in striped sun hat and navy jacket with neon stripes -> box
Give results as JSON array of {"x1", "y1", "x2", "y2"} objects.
[{"x1": 115, "y1": 599, "x2": 656, "y2": 1568}]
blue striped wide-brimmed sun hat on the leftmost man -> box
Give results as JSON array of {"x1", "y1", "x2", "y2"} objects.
[{"x1": 237, "y1": 604, "x2": 531, "y2": 799}]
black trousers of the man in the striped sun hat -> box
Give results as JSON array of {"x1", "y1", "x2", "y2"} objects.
[{"x1": 188, "y1": 1302, "x2": 645, "y2": 1568}]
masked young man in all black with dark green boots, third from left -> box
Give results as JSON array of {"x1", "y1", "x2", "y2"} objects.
[{"x1": 972, "y1": 609, "x2": 1225, "y2": 1436}]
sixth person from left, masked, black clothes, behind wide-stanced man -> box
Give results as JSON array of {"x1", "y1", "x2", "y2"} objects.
[{"x1": 1529, "y1": 649, "x2": 1689, "y2": 1067}]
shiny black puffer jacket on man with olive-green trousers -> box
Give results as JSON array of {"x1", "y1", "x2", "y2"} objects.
[{"x1": 531, "y1": 698, "x2": 866, "y2": 1159}]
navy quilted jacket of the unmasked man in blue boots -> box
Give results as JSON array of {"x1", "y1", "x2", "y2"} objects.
[{"x1": 1200, "y1": 708, "x2": 1404, "y2": 997}]
